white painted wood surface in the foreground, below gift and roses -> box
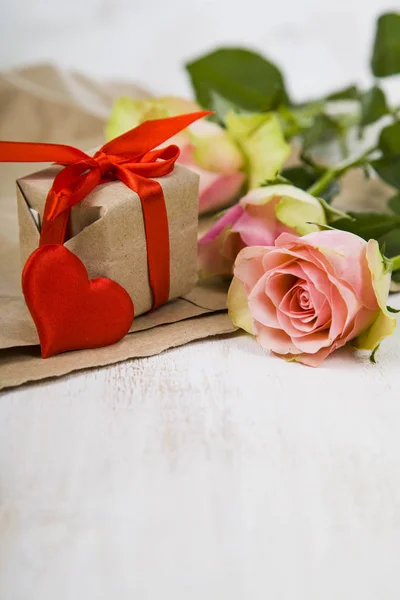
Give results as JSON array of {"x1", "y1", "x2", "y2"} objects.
[{"x1": 0, "y1": 318, "x2": 400, "y2": 600}]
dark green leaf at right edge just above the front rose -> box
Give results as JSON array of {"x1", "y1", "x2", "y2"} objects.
[{"x1": 335, "y1": 212, "x2": 400, "y2": 241}]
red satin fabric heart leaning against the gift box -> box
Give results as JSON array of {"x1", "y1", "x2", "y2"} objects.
[{"x1": 22, "y1": 245, "x2": 134, "y2": 358}]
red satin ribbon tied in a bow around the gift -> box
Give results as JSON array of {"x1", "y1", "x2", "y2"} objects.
[{"x1": 0, "y1": 111, "x2": 211, "y2": 309}]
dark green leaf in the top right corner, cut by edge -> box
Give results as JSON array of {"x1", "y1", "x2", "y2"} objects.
[{"x1": 371, "y1": 13, "x2": 400, "y2": 77}]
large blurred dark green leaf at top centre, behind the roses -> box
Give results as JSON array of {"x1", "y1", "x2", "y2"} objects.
[{"x1": 186, "y1": 48, "x2": 288, "y2": 112}]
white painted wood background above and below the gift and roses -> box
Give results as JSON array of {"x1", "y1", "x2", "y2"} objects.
[{"x1": 0, "y1": 0, "x2": 400, "y2": 600}]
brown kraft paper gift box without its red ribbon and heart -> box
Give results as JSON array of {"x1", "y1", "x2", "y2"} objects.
[{"x1": 17, "y1": 165, "x2": 199, "y2": 316}]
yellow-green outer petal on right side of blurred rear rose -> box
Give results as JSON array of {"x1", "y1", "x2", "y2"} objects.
[{"x1": 225, "y1": 112, "x2": 290, "y2": 188}]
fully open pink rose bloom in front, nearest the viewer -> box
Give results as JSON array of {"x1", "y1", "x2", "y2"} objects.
[{"x1": 228, "y1": 230, "x2": 396, "y2": 367}]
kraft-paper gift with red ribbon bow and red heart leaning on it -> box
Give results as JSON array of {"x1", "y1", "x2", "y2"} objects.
[{"x1": 0, "y1": 112, "x2": 208, "y2": 357}]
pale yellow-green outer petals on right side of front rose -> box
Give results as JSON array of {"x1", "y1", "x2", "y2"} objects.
[{"x1": 356, "y1": 240, "x2": 396, "y2": 350}]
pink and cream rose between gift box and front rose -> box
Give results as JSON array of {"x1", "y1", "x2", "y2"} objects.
[{"x1": 198, "y1": 184, "x2": 326, "y2": 277}]
